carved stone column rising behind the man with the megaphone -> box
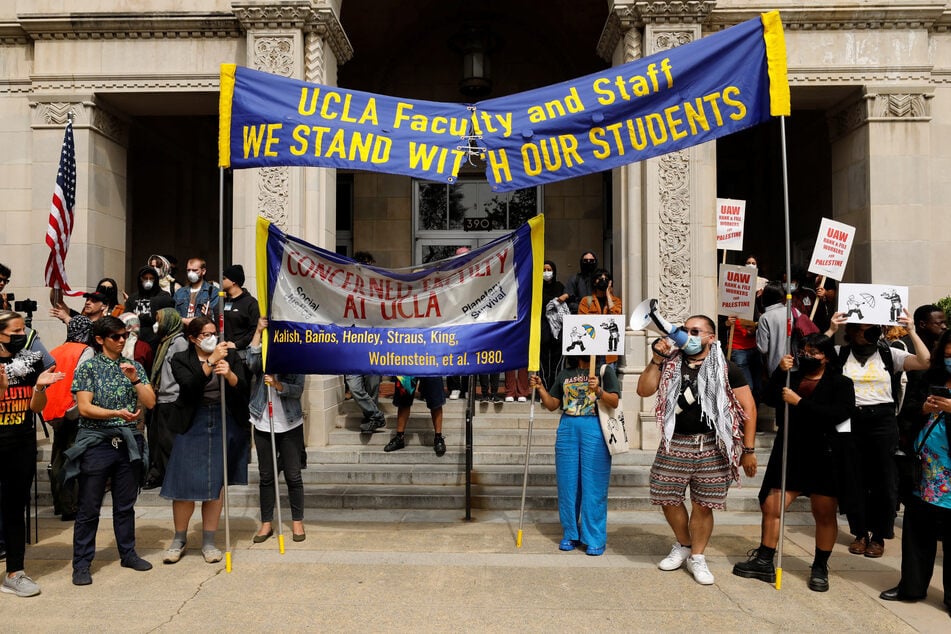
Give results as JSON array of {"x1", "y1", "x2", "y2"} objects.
[{"x1": 598, "y1": 0, "x2": 717, "y2": 448}]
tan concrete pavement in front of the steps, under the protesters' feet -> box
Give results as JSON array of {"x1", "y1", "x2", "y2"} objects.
[{"x1": 0, "y1": 498, "x2": 951, "y2": 633}]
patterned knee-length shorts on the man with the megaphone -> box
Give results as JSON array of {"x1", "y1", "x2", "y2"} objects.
[{"x1": 651, "y1": 432, "x2": 732, "y2": 510}]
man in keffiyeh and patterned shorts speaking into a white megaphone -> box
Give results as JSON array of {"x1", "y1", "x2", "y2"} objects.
[{"x1": 632, "y1": 310, "x2": 756, "y2": 585}]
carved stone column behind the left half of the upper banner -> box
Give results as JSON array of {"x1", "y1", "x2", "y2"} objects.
[{"x1": 232, "y1": 0, "x2": 353, "y2": 446}]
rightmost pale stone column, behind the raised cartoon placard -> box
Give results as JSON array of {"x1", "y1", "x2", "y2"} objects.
[{"x1": 828, "y1": 86, "x2": 932, "y2": 310}]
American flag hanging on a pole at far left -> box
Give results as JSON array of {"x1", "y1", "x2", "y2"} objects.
[{"x1": 46, "y1": 121, "x2": 81, "y2": 295}]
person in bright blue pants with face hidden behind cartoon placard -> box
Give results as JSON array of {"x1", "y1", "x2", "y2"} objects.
[{"x1": 531, "y1": 357, "x2": 621, "y2": 556}]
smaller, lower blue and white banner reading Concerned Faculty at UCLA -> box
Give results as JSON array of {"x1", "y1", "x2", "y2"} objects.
[{"x1": 257, "y1": 216, "x2": 544, "y2": 376}]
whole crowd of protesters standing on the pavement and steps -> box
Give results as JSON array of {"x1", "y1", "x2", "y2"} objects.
[{"x1": 0, "y1": 249, "x2": 951, "y2": 610}]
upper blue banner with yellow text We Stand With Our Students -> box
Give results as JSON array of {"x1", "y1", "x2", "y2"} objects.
[{"x1": 219, "y1": 12, "x2": 789, "y2": 191}]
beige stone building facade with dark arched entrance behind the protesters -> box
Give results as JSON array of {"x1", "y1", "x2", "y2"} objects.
[{"x1": 0, "y1": 0, "x2": 951, "y2": 446}]
